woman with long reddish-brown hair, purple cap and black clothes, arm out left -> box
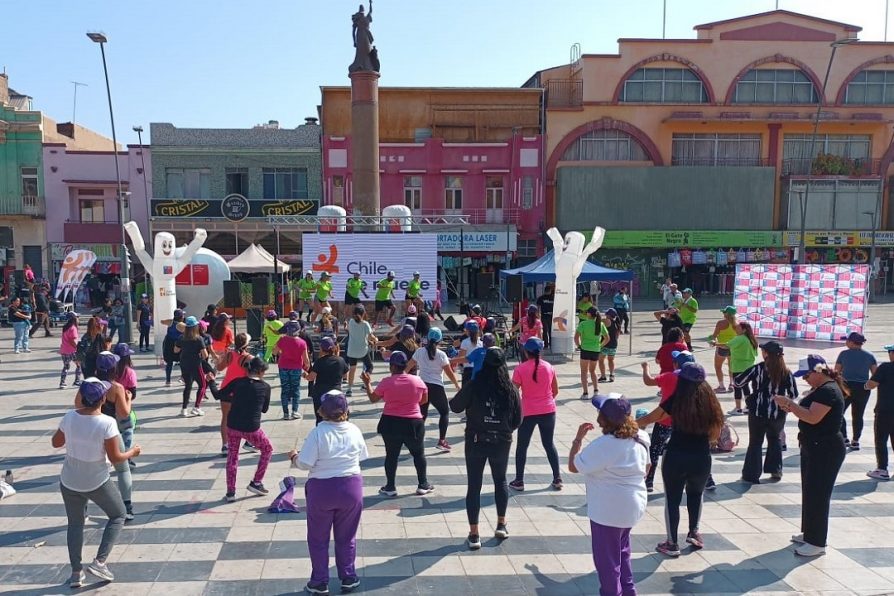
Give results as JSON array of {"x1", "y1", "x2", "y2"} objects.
[{"x1": 637, "y1": 362, "x2": 724, "y2": 557}]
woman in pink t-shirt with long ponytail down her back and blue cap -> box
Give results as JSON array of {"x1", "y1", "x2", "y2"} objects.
[{"x1": 509, "y1": 337, "x2": 562, "y2": 491}]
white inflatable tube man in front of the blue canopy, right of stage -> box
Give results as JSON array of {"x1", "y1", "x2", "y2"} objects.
[{"x1": 546, "y1": 228, "x2": 605, "y2": 357}]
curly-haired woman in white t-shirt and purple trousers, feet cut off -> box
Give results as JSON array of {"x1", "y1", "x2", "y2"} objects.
[{"x1": 568, "y1": 393, "x2": 649, "y2": 596}]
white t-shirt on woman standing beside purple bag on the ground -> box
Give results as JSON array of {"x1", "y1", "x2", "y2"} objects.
[{"x1": 295, "y1": 420, "x2": 369, "y2": 478}]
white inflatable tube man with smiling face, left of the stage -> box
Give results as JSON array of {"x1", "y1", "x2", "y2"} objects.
[{"x1": 124, "y1": 221, "x2": 208, "y2": 356}]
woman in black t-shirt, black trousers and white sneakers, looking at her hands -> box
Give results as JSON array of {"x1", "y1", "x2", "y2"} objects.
[{"x1": 773, "y1": 354, "x2": 848, "y2": 557}]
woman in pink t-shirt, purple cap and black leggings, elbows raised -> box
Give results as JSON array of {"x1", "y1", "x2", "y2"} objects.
[{"x1": 360, "y1": 352, "x2": 435, "y2": 497}]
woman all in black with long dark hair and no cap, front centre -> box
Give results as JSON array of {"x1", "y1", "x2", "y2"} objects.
[{"x1": 450, "y1": 348, "x2": 522, "y2": 550}]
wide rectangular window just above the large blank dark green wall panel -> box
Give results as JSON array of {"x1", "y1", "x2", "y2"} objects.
[{"x1": 671, "y1": 134, "x2": 761, "y2": 166}]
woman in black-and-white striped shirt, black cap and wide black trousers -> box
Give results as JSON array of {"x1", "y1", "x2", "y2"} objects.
[{"x1": 735, "y1": 340, "x2": 798, "y2": 484}]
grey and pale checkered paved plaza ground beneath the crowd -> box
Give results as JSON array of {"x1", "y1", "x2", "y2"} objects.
[{"x1": 0, "y1": 304, "x2": 894, "y2": 596}]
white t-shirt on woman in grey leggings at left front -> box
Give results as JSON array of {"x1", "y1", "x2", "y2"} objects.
[{"x1": 59, "y1": 410, "x2": 119, "y2": 493}]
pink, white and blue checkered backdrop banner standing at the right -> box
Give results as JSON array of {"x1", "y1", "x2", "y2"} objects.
[{"x1": 735, "y1": 265, "x2": 869, "y2": 341}]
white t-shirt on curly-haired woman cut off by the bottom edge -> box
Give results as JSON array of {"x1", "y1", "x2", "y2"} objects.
[{"x1": 574, "y1": 429, "x2": 649, "y2": 528}]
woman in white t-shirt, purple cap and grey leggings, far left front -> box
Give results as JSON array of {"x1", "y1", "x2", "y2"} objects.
[{"x1": 52, "y1": 377, "x2": 141, "y2": 588}]
